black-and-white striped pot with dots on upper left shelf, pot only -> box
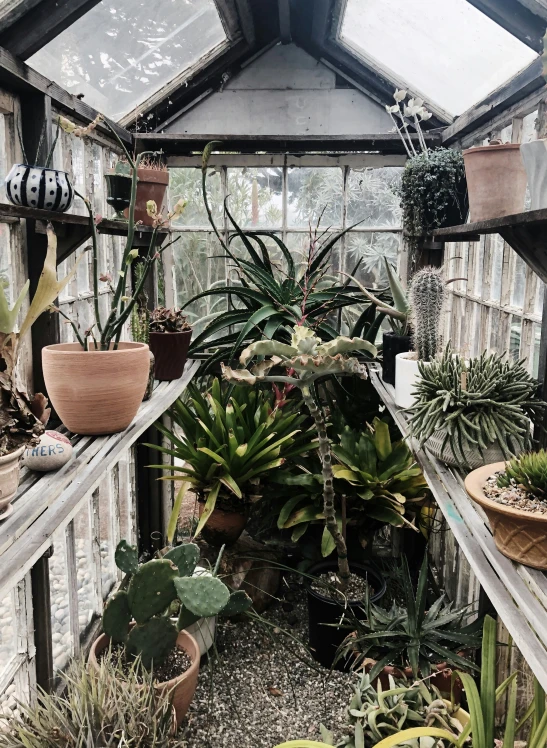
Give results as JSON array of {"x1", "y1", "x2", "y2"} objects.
[{"x1": 5, "y1": 164, "x2": 74, "y2": 213}]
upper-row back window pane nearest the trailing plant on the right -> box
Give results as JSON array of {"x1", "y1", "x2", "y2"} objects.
[{"x1": 346, "y1": 167, "x2": 403, "y2": 228}]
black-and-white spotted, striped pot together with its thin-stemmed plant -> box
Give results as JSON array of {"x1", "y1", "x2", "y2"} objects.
[{"x1": 5, "y1": 118, "x2": 77, "y2": 213}]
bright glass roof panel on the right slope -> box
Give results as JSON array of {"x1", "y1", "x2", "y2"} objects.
[{"x1": 340, "y1": 0, "x2": 537, "y2": 115}]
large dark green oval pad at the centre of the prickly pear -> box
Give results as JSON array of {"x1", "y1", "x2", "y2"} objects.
[{"x1": 127, "y1": 559, "x2": 178, "y2": 623}]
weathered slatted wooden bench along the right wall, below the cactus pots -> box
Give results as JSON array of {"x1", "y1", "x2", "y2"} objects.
[{"x1": 369, "y1": 367, "x2": 547, "y2": 688}]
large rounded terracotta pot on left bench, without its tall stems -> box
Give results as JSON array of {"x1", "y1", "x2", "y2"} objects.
[{"x1": 42, "y1": 343, "x2": 150, "y2": 435}]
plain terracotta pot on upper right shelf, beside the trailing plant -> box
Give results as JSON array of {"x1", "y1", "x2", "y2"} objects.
[{"x1": 463, "y1": 143, "x2": 526, "y2": 223}]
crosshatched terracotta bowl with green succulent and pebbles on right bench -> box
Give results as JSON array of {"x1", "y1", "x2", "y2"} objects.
[{"x1": 465, "y1": 449, "x2": 547, "y2": 569}]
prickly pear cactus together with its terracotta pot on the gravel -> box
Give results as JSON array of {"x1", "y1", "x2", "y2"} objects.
[{"x1": 89, "y1": 541, "x2": 251, "y2": 725}]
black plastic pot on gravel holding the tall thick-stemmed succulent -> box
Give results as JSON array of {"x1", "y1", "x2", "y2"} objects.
[{"x1": 307, "y1": 561, "x2": 386, "y2": 670}]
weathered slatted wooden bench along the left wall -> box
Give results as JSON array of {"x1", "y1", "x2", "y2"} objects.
[{"x1": 0, "y1": 361, "x2": 199, "y2": 599}]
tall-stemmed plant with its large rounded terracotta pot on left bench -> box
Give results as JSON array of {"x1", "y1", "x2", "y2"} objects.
[{"x1": 42, "y1": 117, "x2": 184, "y2": 435}]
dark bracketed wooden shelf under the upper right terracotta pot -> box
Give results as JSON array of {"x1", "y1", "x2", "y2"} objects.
[{"x1": 432, "y1": 208, "x2": 547, "y2": 282}]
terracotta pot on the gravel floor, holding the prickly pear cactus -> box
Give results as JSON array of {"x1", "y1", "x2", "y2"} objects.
[{"x1": 89, "y1": 631, "x2": 200, "y2": 726}]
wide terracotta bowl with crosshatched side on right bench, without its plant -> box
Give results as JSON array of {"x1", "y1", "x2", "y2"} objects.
[{"x1": 465, "y1": 462, "x2": 547, "y2": 569}]
